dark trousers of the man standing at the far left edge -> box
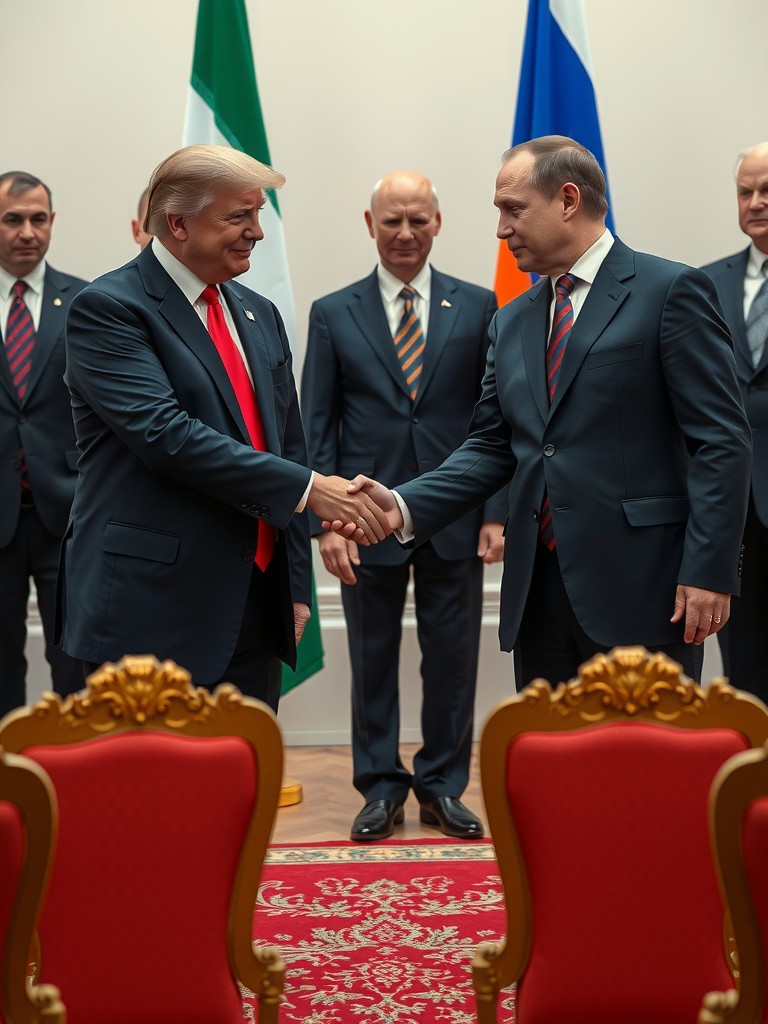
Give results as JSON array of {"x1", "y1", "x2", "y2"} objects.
[{"x1": 0, "y1": 508, "x2": 82, "y2": 715}]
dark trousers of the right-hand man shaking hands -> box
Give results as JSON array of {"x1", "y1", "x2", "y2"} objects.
[{"x1": 514, "y1": 543, "x2": 703, "y2": 690}]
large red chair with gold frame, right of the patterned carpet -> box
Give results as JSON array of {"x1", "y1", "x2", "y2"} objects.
[{"x1": 474, "y1": 648, "x2": 768, "y2": 1024}]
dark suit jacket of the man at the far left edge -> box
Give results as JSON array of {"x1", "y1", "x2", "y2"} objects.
[{"x1": 0, "y1": 266, "x2": 87, "y2": 548}]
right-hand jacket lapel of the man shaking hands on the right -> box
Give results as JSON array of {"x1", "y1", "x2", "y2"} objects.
[{"x1": 551, "y1": 239, "x2": 635, "y2": 413}]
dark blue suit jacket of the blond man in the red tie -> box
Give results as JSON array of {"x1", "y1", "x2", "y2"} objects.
[{"x1": 60, "y1": 247, "x2": 310, "y2": 685}]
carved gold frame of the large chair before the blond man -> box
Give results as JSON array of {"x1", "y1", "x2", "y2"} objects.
[{"x1": 0, "y1": 655, "x2": 285, "y2": 1024}]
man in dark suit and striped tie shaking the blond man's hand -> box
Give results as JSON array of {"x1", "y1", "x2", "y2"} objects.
[{"x1": 336, "y1": 136, "x2": 751, "y2": 684}]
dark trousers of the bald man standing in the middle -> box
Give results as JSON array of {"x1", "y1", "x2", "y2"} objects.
[{"x1": 341, "y1": 544, "x2": 482, "y2": 803}]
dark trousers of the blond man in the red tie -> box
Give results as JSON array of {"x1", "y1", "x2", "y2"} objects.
[{"x1": 83, "y1": 563, "x2": 283, "y2": 712}]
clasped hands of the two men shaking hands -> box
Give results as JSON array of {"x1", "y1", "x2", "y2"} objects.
[{"x1": 307, "y1": 473, "x2": 403, "y2": 546}]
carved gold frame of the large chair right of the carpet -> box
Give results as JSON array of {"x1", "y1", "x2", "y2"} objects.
[{"x1": 472, "y1": 647, "x2": 768, "y2": 1024}]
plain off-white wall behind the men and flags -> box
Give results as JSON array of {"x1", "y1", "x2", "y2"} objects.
[{"x1": 13, "y1": 0, "x2": 768, "y2": 741}]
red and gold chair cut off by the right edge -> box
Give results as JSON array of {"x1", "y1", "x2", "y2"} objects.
[{"x1": 699, "y1": 748, "x2": 768, "y2": 1024}]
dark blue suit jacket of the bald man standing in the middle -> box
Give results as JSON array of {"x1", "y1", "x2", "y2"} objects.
[{"x1": 301, "y1": 269, "x2": 507, "y2": 565}]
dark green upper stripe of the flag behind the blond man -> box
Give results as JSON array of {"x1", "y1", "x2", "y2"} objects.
[{"x1": 190, "y1": 0, "x2": 280, "y2": 213}]
